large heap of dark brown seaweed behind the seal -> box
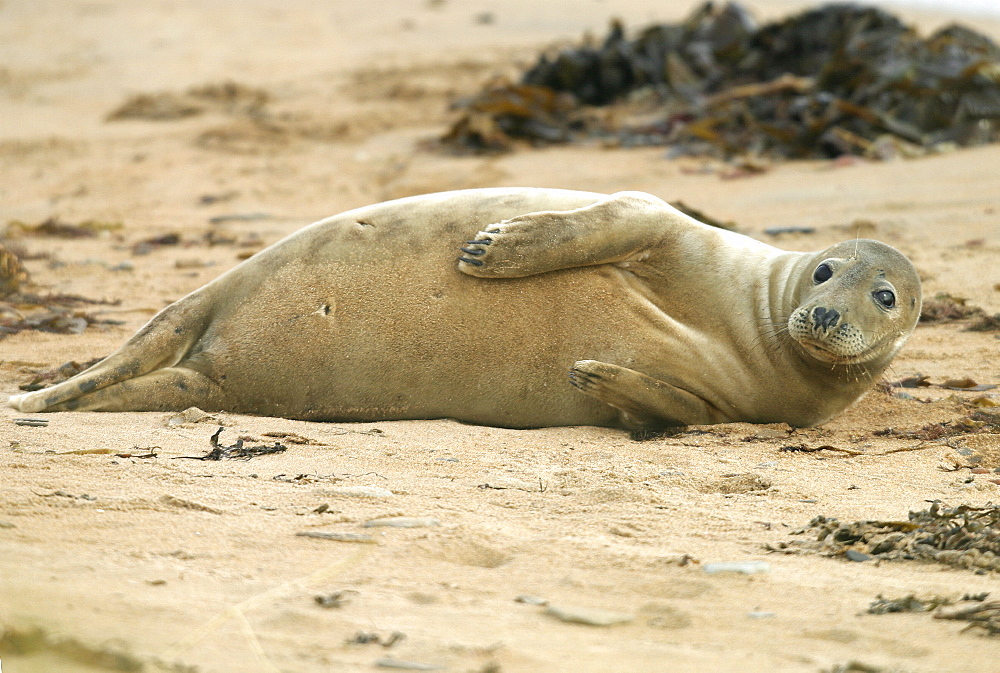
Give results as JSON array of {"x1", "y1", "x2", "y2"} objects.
[{"x1": 443, "y1": 2, "x2": 1000, "y2": 159}]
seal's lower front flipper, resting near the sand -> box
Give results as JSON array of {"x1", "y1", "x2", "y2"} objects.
[{"x1": 569, "y1": 360, "x2": 725, "y2": 429}]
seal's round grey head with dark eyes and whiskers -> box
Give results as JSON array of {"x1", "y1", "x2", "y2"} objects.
[{"x1": 788, "y1": 239, "x2": 921, "y2": 370}]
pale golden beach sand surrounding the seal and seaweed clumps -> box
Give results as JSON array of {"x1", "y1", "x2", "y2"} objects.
[{"x1": 0, "y1": 0, "x2": 1000, "y2": 673}]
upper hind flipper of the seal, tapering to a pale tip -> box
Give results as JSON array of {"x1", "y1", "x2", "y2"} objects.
[{"x1": 7, "y1": 296, "x2": 208, "y2": 413}]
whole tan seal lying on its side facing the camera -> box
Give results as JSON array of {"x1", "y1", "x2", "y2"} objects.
[{"x1": 10, "y1": 188, "x2": 921, "y2": 429}]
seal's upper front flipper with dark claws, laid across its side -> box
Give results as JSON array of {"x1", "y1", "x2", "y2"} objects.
[{"x1": 458, "y1": 192, "x2": 670, "y2": 278}]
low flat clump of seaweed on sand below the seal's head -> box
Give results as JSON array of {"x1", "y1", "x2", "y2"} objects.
[{"x1": 770, "y1": 501, "x2": 1000, "y2": 572}]
